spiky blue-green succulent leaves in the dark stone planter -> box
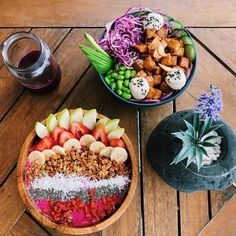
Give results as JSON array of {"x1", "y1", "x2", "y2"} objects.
[{"x1": 171, "y1": 112, "x2": 222, "y2": 171}]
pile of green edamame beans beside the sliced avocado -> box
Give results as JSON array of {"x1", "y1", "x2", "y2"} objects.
[{"x1": 104, "y1": 65, "x2": 137, "y2": 99}]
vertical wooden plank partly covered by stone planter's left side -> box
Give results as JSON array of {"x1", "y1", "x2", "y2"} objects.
[{"x1": 141, "y1": 105, "x2": 178, "y2": 236}]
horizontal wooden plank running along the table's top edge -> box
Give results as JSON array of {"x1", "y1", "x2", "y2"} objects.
[{"x1": 0, "y1": 0, "x2": 236, "y2": 27}]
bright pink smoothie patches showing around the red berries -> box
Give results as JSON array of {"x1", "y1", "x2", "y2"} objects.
[{"x1": 34, "y1": 195, "x2": 124, "y2": 227}]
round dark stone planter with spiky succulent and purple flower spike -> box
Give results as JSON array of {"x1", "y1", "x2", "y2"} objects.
[{"x1": 148, "y1": 85, "x2": 236, "y2": 192}]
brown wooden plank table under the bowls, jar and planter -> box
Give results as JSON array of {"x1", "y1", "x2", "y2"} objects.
[{"x1": 0, "y1": 0, "x2": 236, "y2": 236}]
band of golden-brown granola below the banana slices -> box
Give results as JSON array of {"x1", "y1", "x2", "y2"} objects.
[{"x1": 26, "y1": 150, "x2": 129, "y2": 182}]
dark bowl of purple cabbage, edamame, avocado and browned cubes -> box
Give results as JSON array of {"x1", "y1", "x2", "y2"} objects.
[{"x1": 80, "y1": 8, "x2": 196, "y2": 106}]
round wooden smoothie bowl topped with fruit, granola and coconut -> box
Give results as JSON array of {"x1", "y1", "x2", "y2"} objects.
[{"x1": 17, "y1": 108, "x2": 138, "y2": 235}]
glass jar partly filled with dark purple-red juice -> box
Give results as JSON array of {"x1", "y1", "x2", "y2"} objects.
[{"x1": 2, "y1": 32, "x2": 61, "y2": 92}]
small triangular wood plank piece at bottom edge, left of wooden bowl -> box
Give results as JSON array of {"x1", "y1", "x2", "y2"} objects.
[{"x1": 7, "y1": 213, "x2": 48, "y2": 236}]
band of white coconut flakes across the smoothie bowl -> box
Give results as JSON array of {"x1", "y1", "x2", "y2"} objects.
[{"x1": 31, "y1": 173, "x2": 130, "y2": 194}]
